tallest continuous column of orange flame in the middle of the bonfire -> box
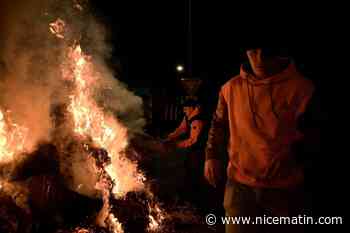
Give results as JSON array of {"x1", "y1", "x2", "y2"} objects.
[{"x1": 63, "y1": 45, "x2": 145, "y2": 197}]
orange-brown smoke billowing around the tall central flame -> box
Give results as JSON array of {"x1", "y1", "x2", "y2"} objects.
[{"x1": 0, "y1": 0, "x2": 145, "y2": 196}]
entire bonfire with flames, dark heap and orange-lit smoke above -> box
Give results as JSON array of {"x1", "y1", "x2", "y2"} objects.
[{"x1": 0, "y1": 0, "x2": 209, "y2": 233}]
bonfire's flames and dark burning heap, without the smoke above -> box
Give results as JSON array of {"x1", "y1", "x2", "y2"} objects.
[{"x1": 0, "y1": 1, "x2": 208, "y2": 233}]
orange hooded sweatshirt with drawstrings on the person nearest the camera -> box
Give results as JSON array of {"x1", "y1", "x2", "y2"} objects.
[{"x1": 206, "y1": 63, "x2": 314, "y2": 188}]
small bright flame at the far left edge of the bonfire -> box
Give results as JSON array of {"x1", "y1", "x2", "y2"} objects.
[{"x1": 0, "y1": 109, "x2": 27, "y2": 163}]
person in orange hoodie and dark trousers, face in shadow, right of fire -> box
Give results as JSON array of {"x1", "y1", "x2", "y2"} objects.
[{"x1": 204, "y1": 48, "x2": 315, "y2": 233}]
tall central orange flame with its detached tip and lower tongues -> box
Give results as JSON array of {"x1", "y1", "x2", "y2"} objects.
[{"x1": 50, "y1": 15, "x2": 165, "y2": 233}]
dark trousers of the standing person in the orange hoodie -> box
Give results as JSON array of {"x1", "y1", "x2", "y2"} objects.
[{"x1": 224, "y1": 180, "x2": 310, "y2": 233}]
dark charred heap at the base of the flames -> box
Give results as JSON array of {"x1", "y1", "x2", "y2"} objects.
[{"x1": 0, "y1": 132, "x2": 211, "y2": 233}]
